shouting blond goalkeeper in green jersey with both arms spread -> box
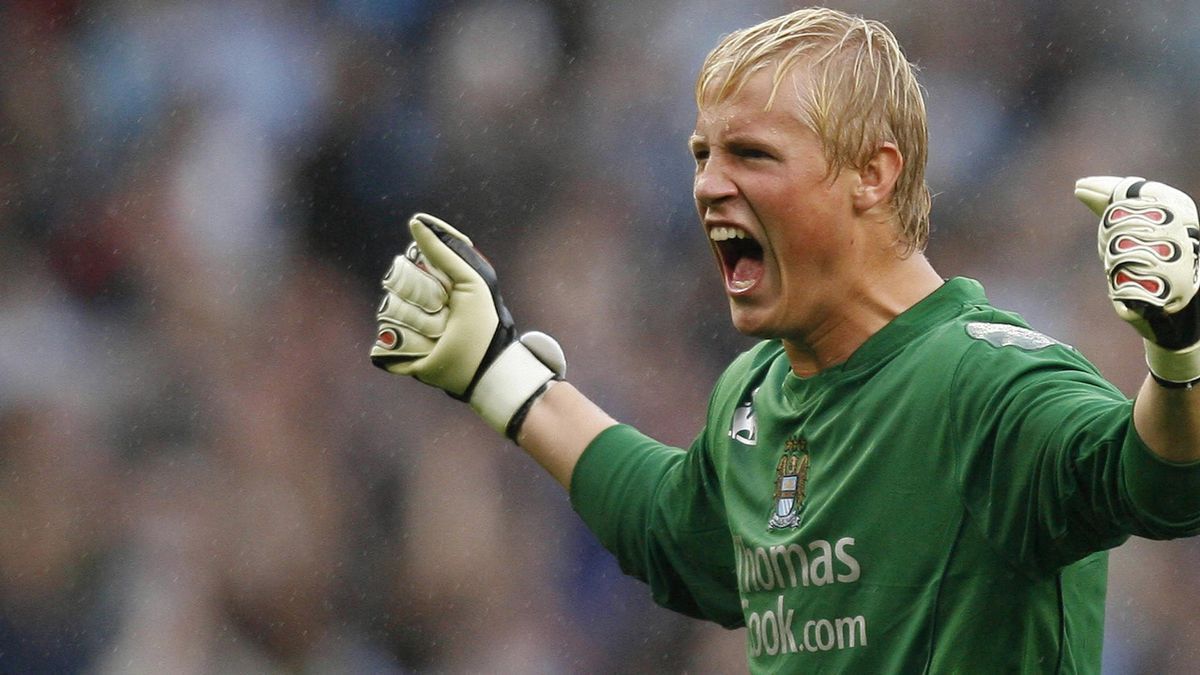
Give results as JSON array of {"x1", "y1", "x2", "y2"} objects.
[{"x1": 371, "y1": 8, "x2": 1200, "y2": 673}]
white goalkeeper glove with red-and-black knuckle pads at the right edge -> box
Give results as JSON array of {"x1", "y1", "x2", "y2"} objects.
[{"x1": 1075, "y1": 175, "x2": 1200, "y2": 387}]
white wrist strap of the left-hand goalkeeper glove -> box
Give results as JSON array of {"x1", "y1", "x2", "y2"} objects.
[{"x1": 470, "y1": 341, "x2": 557, "y2": 438}]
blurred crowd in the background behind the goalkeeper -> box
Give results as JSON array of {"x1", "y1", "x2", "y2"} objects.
[{"x1": 0, "y1": 0, "x2": 1200, "y2": 674}]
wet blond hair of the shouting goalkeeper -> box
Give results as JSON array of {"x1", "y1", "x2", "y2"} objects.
[{"x1": 696, "y1": 7, "x2": 930, "y2": 255}]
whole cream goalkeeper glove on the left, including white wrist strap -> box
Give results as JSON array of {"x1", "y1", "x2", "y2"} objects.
[{"x1": 371, "y1": 214, "x2": 566, "y2": 438}]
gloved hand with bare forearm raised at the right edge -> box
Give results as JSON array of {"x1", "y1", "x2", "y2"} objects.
[{"x1": 1075, "y1": 177, "x2": 1200, "y2": 464}]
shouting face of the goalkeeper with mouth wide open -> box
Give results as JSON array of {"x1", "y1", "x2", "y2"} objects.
[{"x1": 690, "y1": 68, "x2": 865, "y2": 341}]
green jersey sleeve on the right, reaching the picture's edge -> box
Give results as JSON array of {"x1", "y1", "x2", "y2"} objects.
[{"x1": 950, "y1": 333, "x2": 1200, "y2": 572}]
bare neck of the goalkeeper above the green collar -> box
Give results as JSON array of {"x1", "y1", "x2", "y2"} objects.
[{"x1": 782, "y1": 253, "x2": 942, "y2": 377}]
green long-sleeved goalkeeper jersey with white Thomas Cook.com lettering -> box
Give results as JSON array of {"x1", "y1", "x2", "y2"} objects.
[{"x1": 571, "y1": 279, "x2": 1200, "y2": 673}]
